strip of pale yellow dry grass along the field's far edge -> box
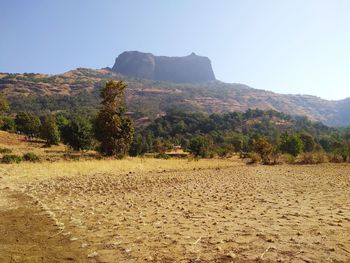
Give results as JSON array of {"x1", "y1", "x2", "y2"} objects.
[{"x1": 0, "y1": 157, "x2": 239, "y2": 185}]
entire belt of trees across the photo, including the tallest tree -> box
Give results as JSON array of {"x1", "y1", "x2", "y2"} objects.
[{"x1": 0, "y1": 81, "x2": 350, "y2": 163}]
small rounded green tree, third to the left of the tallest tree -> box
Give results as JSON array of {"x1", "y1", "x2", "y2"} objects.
[{"x1": 15, "y1": 112, "x2": 41, "y2": 137}]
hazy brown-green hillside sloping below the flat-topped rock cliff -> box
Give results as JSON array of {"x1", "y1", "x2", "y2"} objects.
[{"x1": 0, "y1": 53, "x2": 350, "y2": 126}]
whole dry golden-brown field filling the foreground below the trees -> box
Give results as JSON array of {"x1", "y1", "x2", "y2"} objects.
[{"x1": 0, "y1": 160, "x2": 350, "y2": 262}]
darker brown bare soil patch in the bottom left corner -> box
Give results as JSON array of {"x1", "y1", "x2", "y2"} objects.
[{"x1": 0, "y1": 188, "x2": 93, "y2": 263}]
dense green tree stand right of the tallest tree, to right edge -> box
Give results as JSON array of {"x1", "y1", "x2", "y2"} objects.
[{"x1": 130, "y1": 109, "x2": 350, "y2": 163}]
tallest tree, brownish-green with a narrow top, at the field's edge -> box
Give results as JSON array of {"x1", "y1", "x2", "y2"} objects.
[{"x1": 95, "y1": 80, "x2": 134, "y2": 157}]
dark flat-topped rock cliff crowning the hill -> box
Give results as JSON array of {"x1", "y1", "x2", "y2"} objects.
[{"x1": 112, "y1": 51, "x2": 215, "y2": 83}]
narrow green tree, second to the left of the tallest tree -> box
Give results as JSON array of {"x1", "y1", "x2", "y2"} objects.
[{"x1": 40, "y1": 115, "x2": 60, "y2": 146}]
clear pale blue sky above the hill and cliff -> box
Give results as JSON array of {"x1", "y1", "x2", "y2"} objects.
[{"x1": 0, "y1": 0, "x2": 350, "y2": 99}]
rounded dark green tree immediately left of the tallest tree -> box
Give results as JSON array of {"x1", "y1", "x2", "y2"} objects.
[{"x1": 62, "y1": 116, "x2": 93, "y2": 151}]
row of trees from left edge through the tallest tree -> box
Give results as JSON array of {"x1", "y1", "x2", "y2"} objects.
[{"x1": 0, "y1": 81, "x2": 134, "y2": 157}]
